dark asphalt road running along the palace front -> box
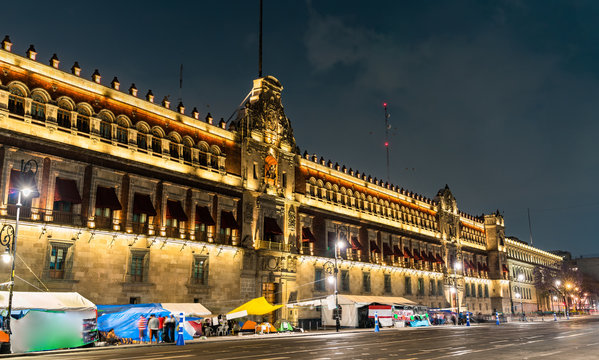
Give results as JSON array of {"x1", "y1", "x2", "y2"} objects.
[{"x1": 18, "y1": 316, "x2": 599, "y2": 360}]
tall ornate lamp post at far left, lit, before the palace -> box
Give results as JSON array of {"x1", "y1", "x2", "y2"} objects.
[{"x1": 0, "y1": 160, "x2": 39, "y2": 348}]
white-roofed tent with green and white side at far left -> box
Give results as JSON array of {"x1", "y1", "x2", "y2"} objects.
[{"x1": 0, "y1": 291, "x2": 97, "y2": 353}]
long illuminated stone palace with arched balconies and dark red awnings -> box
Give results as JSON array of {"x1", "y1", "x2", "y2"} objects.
[{"x1": 0, "y1": 37, "x2": 561, "y2": 320}]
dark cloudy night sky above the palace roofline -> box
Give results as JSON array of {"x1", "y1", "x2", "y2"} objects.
[{"x1": 0, "y1": 0, "x2": 599, "y2": 255}]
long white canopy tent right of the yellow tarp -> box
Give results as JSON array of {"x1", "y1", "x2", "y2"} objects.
[{"x1": 321, "y1": 295, "x2": 417, "y2": 327}]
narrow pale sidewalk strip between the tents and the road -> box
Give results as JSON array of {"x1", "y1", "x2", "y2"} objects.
[{"x1": 0, "y1": 316, "x2": 584, "y2": 358}]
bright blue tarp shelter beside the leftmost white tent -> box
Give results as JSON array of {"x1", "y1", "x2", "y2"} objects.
[{"x1": 98, "y1": 304, "x2": 193, "y2": 340}]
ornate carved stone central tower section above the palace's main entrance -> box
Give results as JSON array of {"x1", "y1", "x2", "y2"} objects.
[{"x1": 233, "y1": 76, "x2": 301, "y2": 326}]
